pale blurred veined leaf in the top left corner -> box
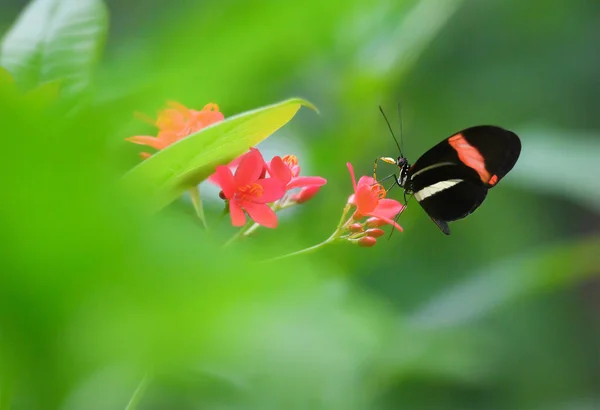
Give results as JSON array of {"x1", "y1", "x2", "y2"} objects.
[{"x1": 0, "y1": 0, "x2": 108, "y2": 97}]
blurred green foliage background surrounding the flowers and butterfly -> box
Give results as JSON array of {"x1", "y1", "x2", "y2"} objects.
[{"x1": 0, "y1": 0, "x2": 600, "y2": 410}]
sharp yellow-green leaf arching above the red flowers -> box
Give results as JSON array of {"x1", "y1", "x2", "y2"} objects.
[{"x1": 122, "y1": 98, "x2": 316, "y2": 212}]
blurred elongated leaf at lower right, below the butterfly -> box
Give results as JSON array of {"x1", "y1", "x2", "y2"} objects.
[{"x1": 411, "y1": 236, "x2": 600, "y2": 329}]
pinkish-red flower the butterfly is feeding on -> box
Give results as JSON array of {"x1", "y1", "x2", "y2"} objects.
[{"x1": 346, "y1": 162, "x2": 404, "y2": 231}]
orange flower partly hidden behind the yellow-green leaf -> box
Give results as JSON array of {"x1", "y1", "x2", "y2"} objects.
[{"x1": 125, "y1": 101, "x2": 224, "y2": 159}]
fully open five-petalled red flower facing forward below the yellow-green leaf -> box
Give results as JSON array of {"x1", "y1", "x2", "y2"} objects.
[{"x1": 213, "y1": 148, "x2": 285, "y2": 228}]
